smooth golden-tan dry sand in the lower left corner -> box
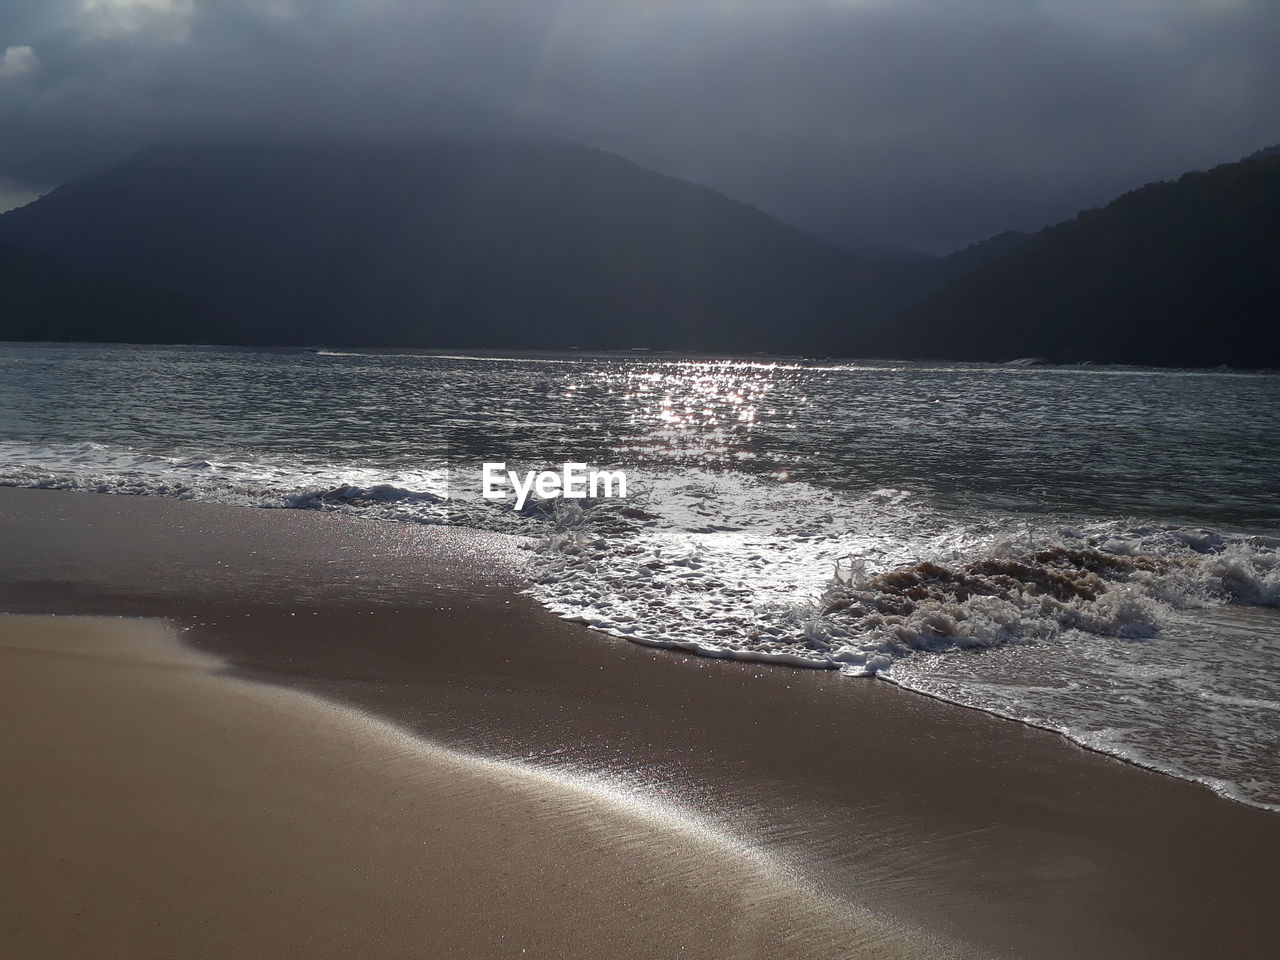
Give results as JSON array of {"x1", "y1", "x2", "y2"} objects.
[{"x1": 0, "y1": 616, "x2": 942, "y2": 960}]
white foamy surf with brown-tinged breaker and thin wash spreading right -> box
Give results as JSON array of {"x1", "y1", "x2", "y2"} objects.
[{"x1": 519, "y1": 491, "x2": 1280, "y2": 810}]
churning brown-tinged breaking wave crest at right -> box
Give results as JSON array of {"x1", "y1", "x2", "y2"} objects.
[{"x1": 809, "y1": 529, "x2": 1280, "y2": 675}]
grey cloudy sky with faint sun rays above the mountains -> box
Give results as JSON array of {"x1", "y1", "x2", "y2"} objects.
[{"x1": 0, "y1": 0, "x2": 1280, "y2": 252}]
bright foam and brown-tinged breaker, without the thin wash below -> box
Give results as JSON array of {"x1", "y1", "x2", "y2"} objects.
[{"x1": 532, "y1": 491, "x2": 1280, "y2": 676}]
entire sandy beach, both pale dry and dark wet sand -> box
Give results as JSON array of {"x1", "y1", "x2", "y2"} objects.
[{"x1": 0, "y1": 489, "x2": 1280, "y2": 957}]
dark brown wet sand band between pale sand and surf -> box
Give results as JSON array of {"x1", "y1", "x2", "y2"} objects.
[{"x1": 0, "y1": 490, "x2": 1280, "y2": 957}]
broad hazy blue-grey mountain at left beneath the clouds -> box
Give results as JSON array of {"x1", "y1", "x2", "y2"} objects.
[{"x1": 0, "y1": 142, "x2": 887, "y2": 352}]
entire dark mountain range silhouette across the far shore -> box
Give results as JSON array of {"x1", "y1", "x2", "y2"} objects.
[{"x1": 0, "y1": 133, "x2": 1280, "y2": 367}]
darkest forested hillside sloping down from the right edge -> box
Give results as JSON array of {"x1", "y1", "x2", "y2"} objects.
[{"x1": 884, "y1": 148, "x2": 1280, "y2": 367}]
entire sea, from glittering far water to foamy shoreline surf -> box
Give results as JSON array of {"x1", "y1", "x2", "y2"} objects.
[{"x1": 0, "y1": 344, "x2": 1280, "y2": 810}]
